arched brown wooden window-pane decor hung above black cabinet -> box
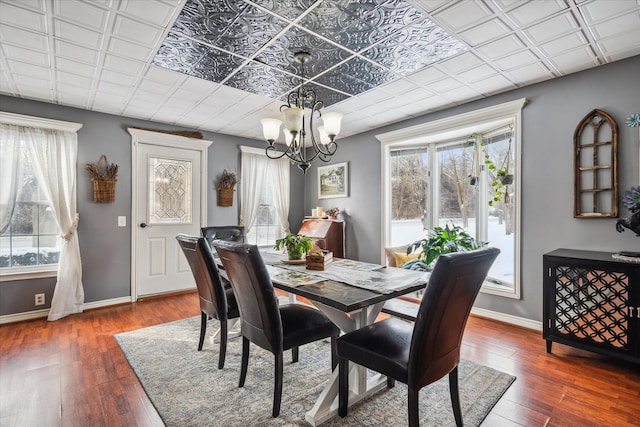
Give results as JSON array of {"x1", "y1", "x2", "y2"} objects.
[{"x1": 573, "y1": 109, "x2": 618, "y2": 218}]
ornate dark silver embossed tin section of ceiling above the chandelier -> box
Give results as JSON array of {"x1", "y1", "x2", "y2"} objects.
[{"x1": 153, "y1": 0, "x2": 466, "y2": 105}]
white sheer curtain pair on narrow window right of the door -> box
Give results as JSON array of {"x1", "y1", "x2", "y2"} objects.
[{"x1": 240, "y1": 147, "x2": 290, "y2": 233}]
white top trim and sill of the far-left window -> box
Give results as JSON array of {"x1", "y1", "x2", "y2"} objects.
[{"x1": 0, "y1": 111, "x2": 82, "y2": 282}]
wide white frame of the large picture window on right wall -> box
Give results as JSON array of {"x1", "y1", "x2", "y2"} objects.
[{"x1": 376, "y1": 98, "x2": 527, "y2": 299}]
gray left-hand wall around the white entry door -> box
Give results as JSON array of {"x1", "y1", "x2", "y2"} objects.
[{"x1": 0, "y1": 96, "x2": 304, "y2": 315}]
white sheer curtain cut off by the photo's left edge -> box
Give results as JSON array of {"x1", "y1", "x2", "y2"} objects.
[{"x1": 0, "y1": 124, "x2": 20, "y2": 234}]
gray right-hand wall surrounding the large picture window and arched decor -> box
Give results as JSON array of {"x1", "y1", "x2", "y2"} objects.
[{"x1": 305, "y1": 56, "x2": 640, "y2": 320}]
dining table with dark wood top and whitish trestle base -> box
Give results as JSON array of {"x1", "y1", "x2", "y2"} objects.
[{"x1": 262, "y1": 251, "x2": 429, "y2": 426}]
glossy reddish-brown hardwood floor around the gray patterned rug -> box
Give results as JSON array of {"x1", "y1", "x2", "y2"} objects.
[{"x1": 0, "y1": 293, "x2": 640, "y2": 427}]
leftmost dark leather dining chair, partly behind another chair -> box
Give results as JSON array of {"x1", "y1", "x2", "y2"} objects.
[{"x1": 176, "y1": 234, "x2": 240, "y2": 369}]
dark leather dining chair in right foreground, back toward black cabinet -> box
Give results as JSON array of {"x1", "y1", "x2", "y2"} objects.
[{"x1": 337, "y1": 248, "x2": 500, "y2": 427}]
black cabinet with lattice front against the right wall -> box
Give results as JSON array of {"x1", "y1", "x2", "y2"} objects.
[{"x1": 543, "y1": 249, "x2": 640, "y2": 363}]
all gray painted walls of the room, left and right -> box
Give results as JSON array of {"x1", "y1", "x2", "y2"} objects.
[{"x1": 0, "y1": 56, "x2": 640, "y2": 320}]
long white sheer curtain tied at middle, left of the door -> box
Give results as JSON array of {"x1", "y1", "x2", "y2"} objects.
[{"x1": 21, "y1": 127, "x2": 84, "y2": 320}]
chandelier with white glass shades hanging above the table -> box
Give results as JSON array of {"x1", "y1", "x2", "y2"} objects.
[{"x1": 260, "y1": 52, "x2": 342, "y2": 173}]
